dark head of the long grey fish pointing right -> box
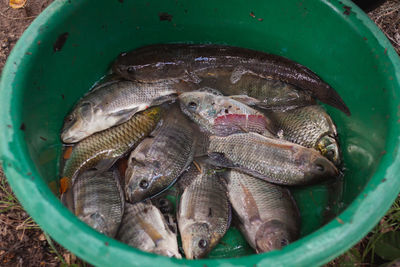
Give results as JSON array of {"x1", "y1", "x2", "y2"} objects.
[{"x1": 304, "y1": 151, "x2": 339, "y2": 183}]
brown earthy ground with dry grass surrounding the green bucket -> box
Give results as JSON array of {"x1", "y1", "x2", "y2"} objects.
[{"x1": 0, "y1": 0, "x2": 400, "y2": 266}]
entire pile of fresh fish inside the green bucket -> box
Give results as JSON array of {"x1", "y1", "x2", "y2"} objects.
[{"x1": 60, "y1": 44, "x2": 350, "y2": 259}]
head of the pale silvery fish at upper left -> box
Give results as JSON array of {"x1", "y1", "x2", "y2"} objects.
[{"x1": 61, "y1": 102, "x2": 94, "y2": 143}]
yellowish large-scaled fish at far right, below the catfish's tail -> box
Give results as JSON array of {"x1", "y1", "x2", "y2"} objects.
[{"x1": 268, "y1": 105, "x2": 340, "y2": 166}]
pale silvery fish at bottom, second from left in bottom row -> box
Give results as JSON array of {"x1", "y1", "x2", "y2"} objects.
[{"x1": 117, "y1": 202, "x2": 182, "y2": 259}]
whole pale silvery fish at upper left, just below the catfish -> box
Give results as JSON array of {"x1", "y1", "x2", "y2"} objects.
[{"x1": 61, "y1": 80, "x2": 189, "y2": 143}]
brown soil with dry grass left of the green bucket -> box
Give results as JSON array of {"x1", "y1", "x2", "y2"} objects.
[{"x1": 0, "y1": 0, "x2": 73, "y2": 266}]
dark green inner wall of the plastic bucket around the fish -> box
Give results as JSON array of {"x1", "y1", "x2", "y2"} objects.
[{"x1": 2, "y1": 0, "x2": 397, "y2": 264}]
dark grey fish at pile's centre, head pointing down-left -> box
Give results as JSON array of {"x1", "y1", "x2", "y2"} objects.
[{"x1": 125, "y1": 105, "x2": 196, "y2": 203}]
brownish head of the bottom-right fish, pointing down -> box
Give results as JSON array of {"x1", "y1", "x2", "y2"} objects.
[{"x1": 255, "y1": 220, "x2": 292, "y2": 253}]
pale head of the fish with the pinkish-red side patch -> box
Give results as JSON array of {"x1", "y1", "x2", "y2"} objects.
[{"x1": 178, "y1": 92, "x2": 218, "y2": 132}]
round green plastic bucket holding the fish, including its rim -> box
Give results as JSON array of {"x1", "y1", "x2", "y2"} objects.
[{"x1": 0, "y1": 0, "x2": 400, "y2": 266}]
